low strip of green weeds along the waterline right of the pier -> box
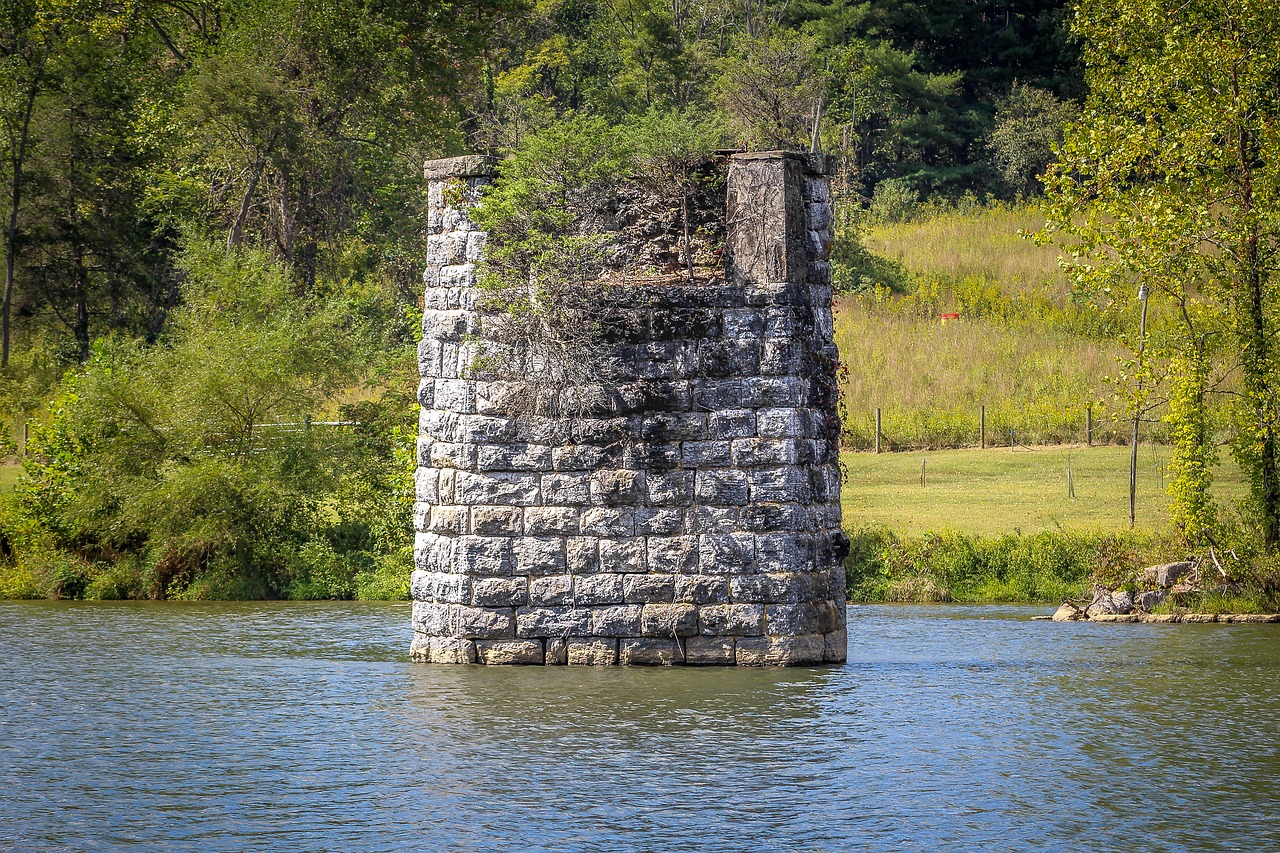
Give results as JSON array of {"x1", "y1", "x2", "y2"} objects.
[{"x1": 845, "y1": 528, "x2": 1178, "y2": 603}]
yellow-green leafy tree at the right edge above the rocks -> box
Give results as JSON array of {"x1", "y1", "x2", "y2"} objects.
[{"x1": 1048, "y1": 0, "x2": 1280, "y2": 551}]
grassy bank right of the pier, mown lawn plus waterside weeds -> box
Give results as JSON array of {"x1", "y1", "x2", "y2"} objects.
[{"x1": 841, "y1": 446, "x2": 1245, "y2": 602}]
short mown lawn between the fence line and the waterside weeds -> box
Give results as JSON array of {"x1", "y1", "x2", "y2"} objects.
[{"x1": 841, "y1": 446, "x2": 1244, "y2": 535}]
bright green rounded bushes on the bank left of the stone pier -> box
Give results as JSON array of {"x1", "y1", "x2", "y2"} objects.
[{"x1": 5, "y1": 247, "x2": 412, "y2": 598}]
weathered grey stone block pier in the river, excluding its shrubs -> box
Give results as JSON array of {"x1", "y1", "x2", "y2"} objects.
[{"x1": 411, "y1": 152, "x2": 847, "y2": 666}]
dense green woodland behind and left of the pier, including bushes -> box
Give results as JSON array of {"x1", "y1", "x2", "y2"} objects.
[{"x1": 0, "y1": 0, "x2": 1280, "y2": 598}]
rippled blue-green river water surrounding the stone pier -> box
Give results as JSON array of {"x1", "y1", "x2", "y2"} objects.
[{"x1": 0, "y1": 602, "x2": 1280, "y2": 853}]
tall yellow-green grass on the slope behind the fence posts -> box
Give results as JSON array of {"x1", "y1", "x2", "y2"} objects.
[{"x1": 836, "y1": 206, "x2": 1162, "y2": 450}]
